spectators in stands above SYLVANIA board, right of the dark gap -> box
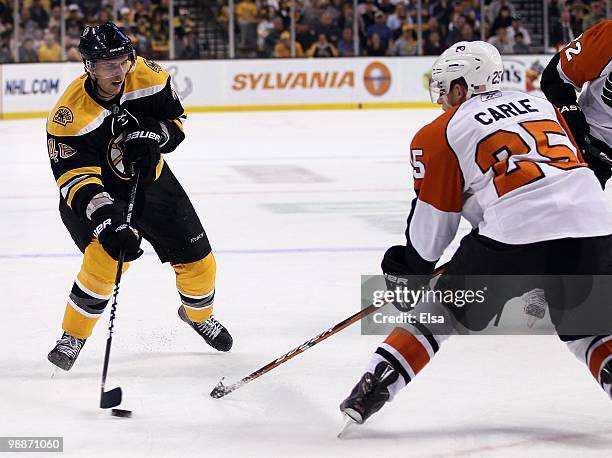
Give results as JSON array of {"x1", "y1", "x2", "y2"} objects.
[{"x1": 225, "y1": 0, "x2": 606, "y2": 57}]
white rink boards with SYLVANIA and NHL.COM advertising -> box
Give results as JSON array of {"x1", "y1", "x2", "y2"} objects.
[{"x1": 0, "y1": 55, "x2": 551, "y2": 119}]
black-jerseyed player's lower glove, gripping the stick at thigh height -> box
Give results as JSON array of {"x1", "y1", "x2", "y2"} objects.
[{"x1": 91, "y1": 201, "x2": 143, "y2": 262}]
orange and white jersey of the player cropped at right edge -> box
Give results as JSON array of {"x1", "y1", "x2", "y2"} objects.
[{"x1": 557, "y1": 20, "x2": 612, "y2": 145}]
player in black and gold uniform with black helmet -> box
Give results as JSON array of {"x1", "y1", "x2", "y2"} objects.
[{"x1": 47, "y1": 23, "x2": 232, "y2": 370}]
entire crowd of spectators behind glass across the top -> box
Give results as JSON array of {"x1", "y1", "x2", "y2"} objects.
[{"x1": 0, "y1": 0, "x2": 606, "y2": 63}]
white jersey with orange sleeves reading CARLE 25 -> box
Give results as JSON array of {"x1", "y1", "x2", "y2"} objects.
[{"x1": 407, "y1": 91, "x2": 612, "y2": 261}]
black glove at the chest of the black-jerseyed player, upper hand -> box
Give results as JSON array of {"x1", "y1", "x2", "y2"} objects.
[{"x1": 123, "y1": 119, "x2": 164, "y2": 182}]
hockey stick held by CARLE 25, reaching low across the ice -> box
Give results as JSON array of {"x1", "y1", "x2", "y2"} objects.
[{"x1": 210, "y1": 264, "x2": 446, "y2": 399}]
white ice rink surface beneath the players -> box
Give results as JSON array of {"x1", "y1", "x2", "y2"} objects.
[{"x1": 0, "y1": 110, "x2": 612, "y2": 457}]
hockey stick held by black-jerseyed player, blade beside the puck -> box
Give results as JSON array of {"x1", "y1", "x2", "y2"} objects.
[{"x1": 100, "y1": 164, "x2": 140, "y2": 409}]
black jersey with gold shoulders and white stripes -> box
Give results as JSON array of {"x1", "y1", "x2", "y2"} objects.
[{"x1": 47, "y1": 57, "x2": 185, "y2": 216}]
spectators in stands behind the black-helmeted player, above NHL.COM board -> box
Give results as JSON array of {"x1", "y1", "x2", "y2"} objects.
[{"x1": 0, "y1": 0, "x2": 200, "y2": 63}]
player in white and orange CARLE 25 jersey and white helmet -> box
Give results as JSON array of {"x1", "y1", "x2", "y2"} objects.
[{"x1": 340, "y1": 41, "x2": 612, "y2": 423}]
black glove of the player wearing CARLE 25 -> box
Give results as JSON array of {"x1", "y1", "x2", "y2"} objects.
[{"x1": 380, "y1": 245, "x2": 431, "y2": 312}]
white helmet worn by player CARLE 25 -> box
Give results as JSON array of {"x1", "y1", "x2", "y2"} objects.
[{"x1": 429, "y1": 41, "x2": 504, "y2": 103}]
